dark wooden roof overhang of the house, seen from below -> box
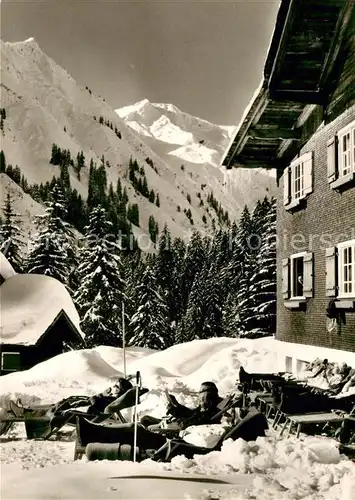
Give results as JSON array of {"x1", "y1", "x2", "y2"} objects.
[{"x1": 223, "y1": 0, "x2": 354, "y2": 169}]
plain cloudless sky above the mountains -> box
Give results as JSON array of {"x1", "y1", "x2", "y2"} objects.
[{"x1": 1, "y1": 0, "x2": 279, "y2": 125}]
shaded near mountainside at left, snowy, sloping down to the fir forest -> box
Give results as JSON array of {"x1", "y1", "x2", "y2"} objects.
[{"x1": 1, "y1": 39, "x2": 202, "y2": 240}]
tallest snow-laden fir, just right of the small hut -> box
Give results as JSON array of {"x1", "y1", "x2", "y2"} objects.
[{"x1": 75, "y1": 206, "x2": 125, "y2": 347}]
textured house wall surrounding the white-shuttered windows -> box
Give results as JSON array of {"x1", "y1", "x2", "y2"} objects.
[{"x1": 276, "y1": 105, "x2": 355, "y2": 352}]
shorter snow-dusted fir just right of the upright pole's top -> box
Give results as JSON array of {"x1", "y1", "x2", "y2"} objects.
[{"x1": 130, "y1": 266, "x2": 172, "y2": 349}]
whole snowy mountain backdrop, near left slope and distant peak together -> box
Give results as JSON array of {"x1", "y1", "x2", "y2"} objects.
[{"x1": 1, "y1": 38, "x2": 274, "y2": 246}]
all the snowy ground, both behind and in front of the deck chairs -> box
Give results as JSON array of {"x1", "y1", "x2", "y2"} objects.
[{"x1": 0, "y1": 338, "x2": 355, "y2": 500}]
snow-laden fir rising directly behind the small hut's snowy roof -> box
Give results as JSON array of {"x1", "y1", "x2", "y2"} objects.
[{"x1": 26, "y1": 183, "x2": 75, "y2": 285}]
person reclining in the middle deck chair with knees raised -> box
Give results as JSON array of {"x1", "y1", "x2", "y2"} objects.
[{"x1": 141, "y1": 382, "x2": 229, "y2": 431}]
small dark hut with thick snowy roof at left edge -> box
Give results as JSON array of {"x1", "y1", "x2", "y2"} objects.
[{"x1": 0, "y1": 254, "x2": 84, "y2": 375}]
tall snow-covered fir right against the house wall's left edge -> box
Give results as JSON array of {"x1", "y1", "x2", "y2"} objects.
[{"x1": 222, "y1": 198, "x2": 276, "y2": 338}]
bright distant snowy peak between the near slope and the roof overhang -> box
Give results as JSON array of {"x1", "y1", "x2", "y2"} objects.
[{"x1": 116, "y1": 99, "x2": 276, "y2": 219}]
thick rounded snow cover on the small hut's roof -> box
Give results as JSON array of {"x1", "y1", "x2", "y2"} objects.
[{"x1": 0, "y1": 274, "x2": 83, "y2": 345}]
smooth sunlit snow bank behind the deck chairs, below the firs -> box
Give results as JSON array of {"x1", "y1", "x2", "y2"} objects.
[{"x1": 0, "y1": 337, "x2": 276, "y2": 410}]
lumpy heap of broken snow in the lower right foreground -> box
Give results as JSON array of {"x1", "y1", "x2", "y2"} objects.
[{"x1": 156, "y1": 432, "x2": 355, "y2": 500}]
